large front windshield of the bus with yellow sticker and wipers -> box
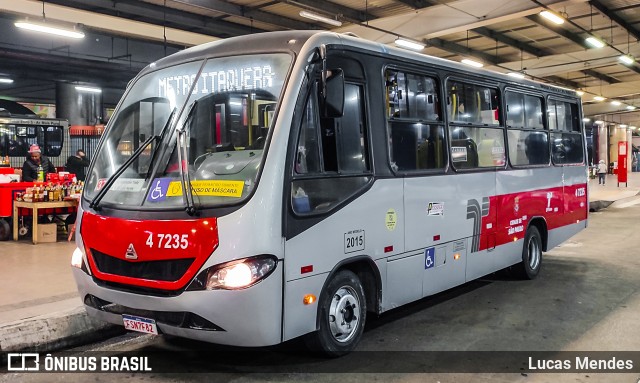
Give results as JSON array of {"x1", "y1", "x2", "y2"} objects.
[{"x1": 85, "y1": 53, "x2": 291, "y2": 209}]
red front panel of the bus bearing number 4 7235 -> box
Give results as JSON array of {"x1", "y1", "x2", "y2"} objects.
[{"x1": 81, "y1": 212, "x2": 218, "y2": 290}]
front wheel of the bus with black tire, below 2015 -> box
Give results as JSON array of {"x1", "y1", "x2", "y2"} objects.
[{"x1": 305, "y1": 270, "x2": 367, "y2": 358}]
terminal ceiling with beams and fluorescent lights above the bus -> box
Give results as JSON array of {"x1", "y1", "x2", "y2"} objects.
[{"x1": 0, "y1": 0, "x2": 640, "y2": 127}]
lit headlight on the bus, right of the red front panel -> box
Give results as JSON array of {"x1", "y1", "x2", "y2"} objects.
[{"x1": 187, "y1": 255, "x2": 278, "y2": 290}]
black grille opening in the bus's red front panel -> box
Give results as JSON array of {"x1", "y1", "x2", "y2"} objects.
[{"x1": 91, "y1": 249, "x2": 195, "y2": 282}]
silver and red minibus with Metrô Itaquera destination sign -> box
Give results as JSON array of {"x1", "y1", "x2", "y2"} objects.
[{"x1": 72, "y1": 32, "x2": 588, "y2": 355}]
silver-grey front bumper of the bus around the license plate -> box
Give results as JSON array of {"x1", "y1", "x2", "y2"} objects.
[{"x1": 72, "y1": 267, "x2": 283, "y2": 347}]
